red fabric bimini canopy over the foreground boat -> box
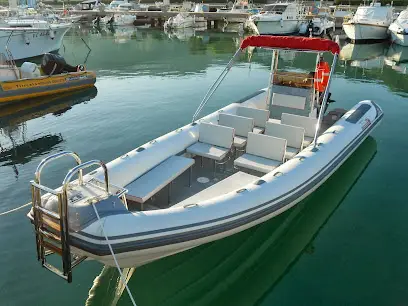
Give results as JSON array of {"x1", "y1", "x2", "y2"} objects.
[{"x1": 241, "y1": 35, "x2": 340, "y2": 54}]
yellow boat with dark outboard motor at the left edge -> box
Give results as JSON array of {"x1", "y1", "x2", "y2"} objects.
[{"x1": 0, "y1": 53, "x2": 96, "y2": 106}]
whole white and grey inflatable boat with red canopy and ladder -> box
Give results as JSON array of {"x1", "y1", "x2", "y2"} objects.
[{"x1": 28, "y1": 36, "x2": 383, "y2": 282}]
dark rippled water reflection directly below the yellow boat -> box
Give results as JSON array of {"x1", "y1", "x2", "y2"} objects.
[{"x1": 0, "y1": 87, "x2": 97, "y2": 177}]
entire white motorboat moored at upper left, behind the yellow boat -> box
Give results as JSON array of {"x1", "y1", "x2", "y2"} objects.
[{"x1": 0, "y1": 19, "x2": 72, "y2": 60}]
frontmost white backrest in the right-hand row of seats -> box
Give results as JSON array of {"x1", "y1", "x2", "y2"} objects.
[{"x1": 246, "y1": 133, "x2": 286, "y2": 162}]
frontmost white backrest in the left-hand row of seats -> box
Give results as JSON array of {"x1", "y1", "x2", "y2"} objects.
[{"x1": 198, "y1": 122, "x2": 234, "y2": 149}]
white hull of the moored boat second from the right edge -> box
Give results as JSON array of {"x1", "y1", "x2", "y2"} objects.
[{"x1": 343, "y1": 23, "x2": 388, "y2": 41}]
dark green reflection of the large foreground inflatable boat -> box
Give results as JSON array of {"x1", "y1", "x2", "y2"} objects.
[{"x1": 86, "y1": 137, "x2": 377, "y2": 306}]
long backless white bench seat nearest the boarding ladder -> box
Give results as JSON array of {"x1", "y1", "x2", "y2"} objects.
[{"x1": 125, "y1": 156, "x2": 195, "y2": 208}]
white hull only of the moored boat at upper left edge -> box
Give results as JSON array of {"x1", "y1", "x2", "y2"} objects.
[{"x1": 0, "y1": 24, "x2": 71, "y2": 60}]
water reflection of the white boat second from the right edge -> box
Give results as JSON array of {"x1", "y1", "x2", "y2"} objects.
[{"x1": 340, "y1": 42, "x2": 388, "y2": 69}]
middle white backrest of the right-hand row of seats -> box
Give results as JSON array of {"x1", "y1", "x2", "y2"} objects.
[{"x1": 265, "y1": 122, "x2": 305, "y2": 149}]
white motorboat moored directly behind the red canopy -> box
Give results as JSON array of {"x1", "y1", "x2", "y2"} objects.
[{"x1": 249, "y1": 2, "x2": 306, "y2": 35}]
